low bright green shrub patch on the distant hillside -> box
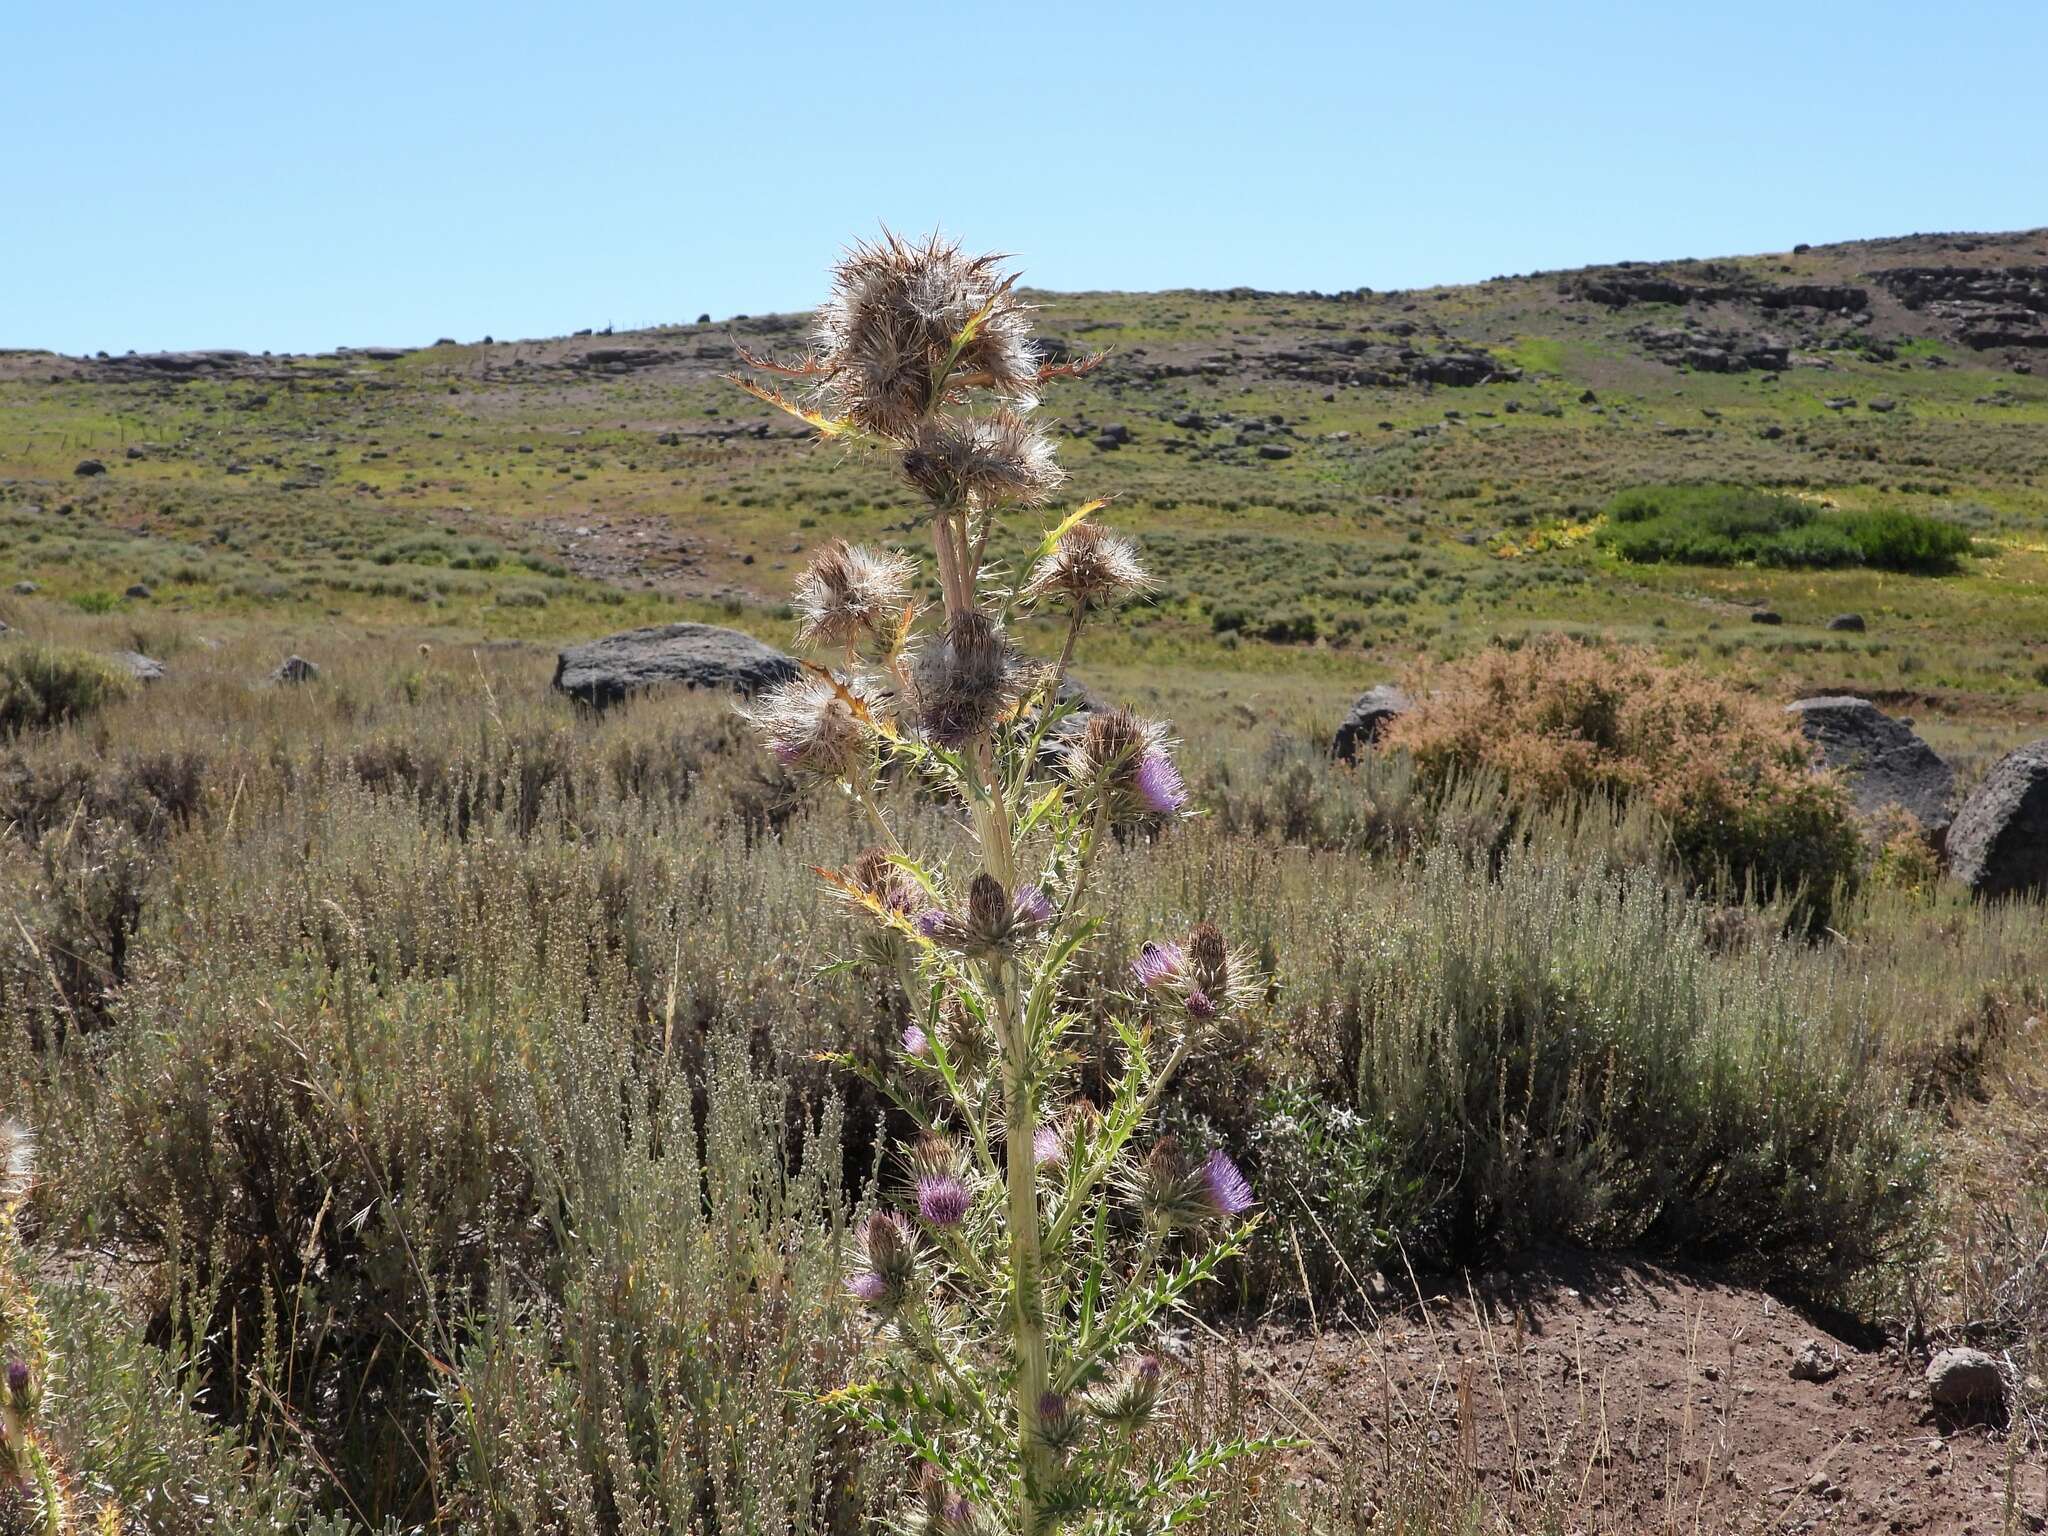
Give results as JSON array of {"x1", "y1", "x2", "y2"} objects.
[{"x1": 1597, "y1": 485, "x2": 1970, "y2": 575}]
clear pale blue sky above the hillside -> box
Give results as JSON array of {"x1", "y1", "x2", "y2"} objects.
[{"x1": 0, "y1": 0, "x2": 2048, "y2": 352}]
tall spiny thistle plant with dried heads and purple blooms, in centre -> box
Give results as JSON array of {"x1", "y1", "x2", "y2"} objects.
[{"x1": 733, "y1": 233, "x2": 1272, "y2": 1536}]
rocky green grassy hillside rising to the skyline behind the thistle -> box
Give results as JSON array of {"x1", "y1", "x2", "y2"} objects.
[{"x1": 0, "y1": 231, "x2": 2048, "y2": 761}]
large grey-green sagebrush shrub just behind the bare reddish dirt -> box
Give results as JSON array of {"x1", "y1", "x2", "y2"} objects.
[{"x1": 1327, "y1": 848, "x2": 1925, "y2": 1288}]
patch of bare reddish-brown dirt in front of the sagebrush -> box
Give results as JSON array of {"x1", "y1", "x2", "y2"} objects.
[{"x1": 1245, "y1": 1253, "x2": 2048, "y2": 1536}]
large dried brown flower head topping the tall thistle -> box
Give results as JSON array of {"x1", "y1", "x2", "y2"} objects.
[{"x1": 813, "y1": 229, "x2": 1038, "y2": 438}]
